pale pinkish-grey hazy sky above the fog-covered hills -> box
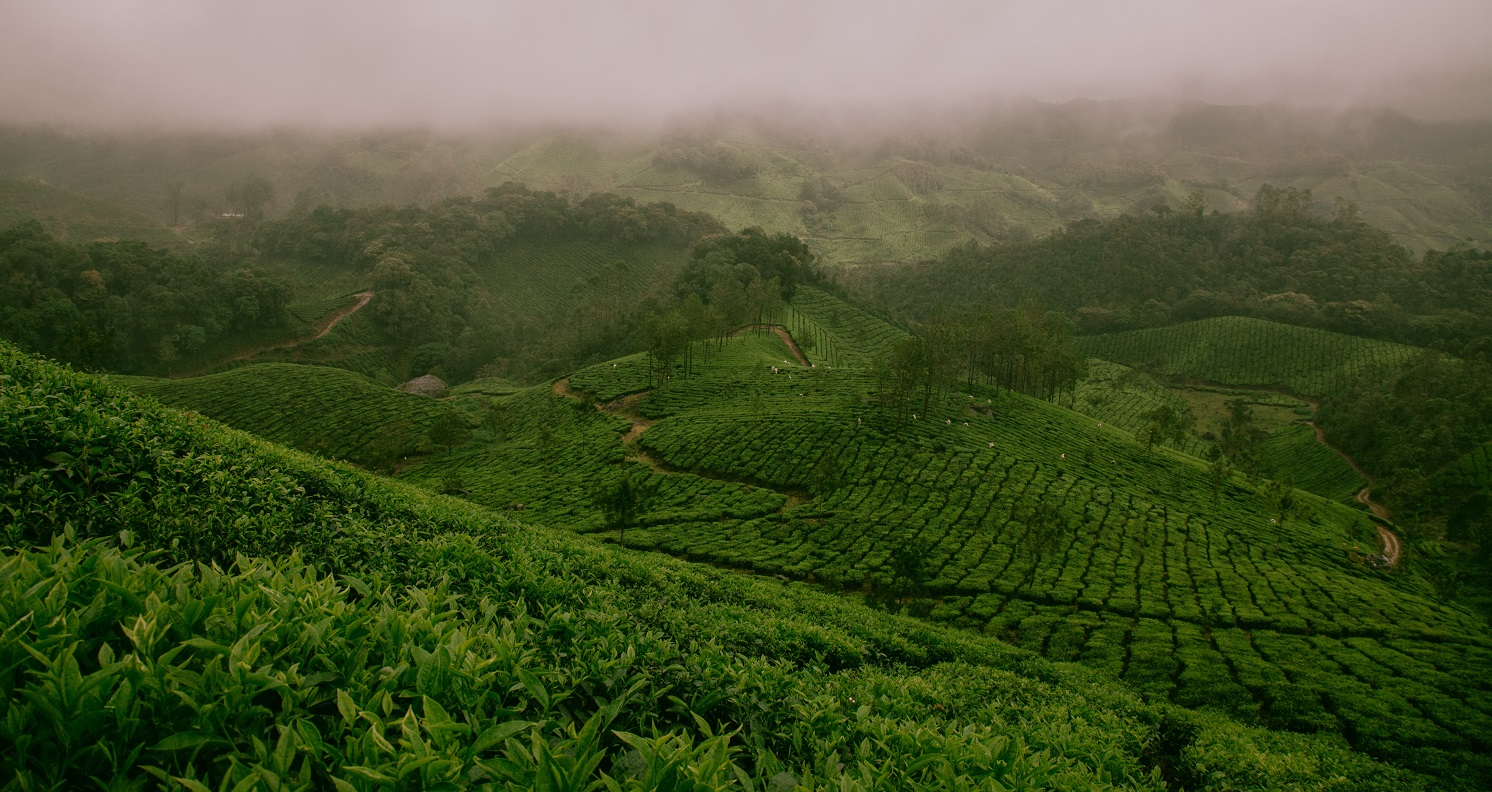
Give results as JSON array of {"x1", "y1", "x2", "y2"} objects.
[{"x1": 0, "y1": 0, "x2": 1492, "y2": 127}]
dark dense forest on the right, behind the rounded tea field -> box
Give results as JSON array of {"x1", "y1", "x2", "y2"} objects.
[{"x1": 852, "y1": 185, "x2": 1492, "y2": 353}]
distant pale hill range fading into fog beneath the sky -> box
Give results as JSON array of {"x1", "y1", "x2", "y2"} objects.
[{"x1": 0, "y1": 100, "x2": 1492, "y2": 264}]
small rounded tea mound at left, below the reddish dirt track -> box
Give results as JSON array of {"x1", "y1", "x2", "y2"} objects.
[{"x1": 118, "y1": 362, "x2": 460, "y2": 465}]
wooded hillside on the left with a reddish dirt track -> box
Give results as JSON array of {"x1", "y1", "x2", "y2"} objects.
[{"x1": 0, "y1": 183, "x2": 722, "y2": 383}]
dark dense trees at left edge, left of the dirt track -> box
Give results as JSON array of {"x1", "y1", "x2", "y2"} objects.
[{"x1": 0, "y1": 221, "x2": 291, "y2": 373}]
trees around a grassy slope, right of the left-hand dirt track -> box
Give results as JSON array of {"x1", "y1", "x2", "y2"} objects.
[{"x1": 255, "y1": 182, "x2": 722, "y2": 379}]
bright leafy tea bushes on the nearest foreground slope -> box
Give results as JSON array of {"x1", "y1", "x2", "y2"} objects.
[{"x1": 0, "y1": 346, "x2": 1432, "y2": 791}]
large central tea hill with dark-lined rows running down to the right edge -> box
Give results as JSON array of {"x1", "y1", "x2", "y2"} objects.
[{"x1": 510, "y1": 304, "x2": 1492, "y2": 767}]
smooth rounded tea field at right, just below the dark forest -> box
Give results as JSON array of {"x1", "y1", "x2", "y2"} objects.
[{"x1": 1079, "y1": 316, "x2": 1419, "y2": 397}]
